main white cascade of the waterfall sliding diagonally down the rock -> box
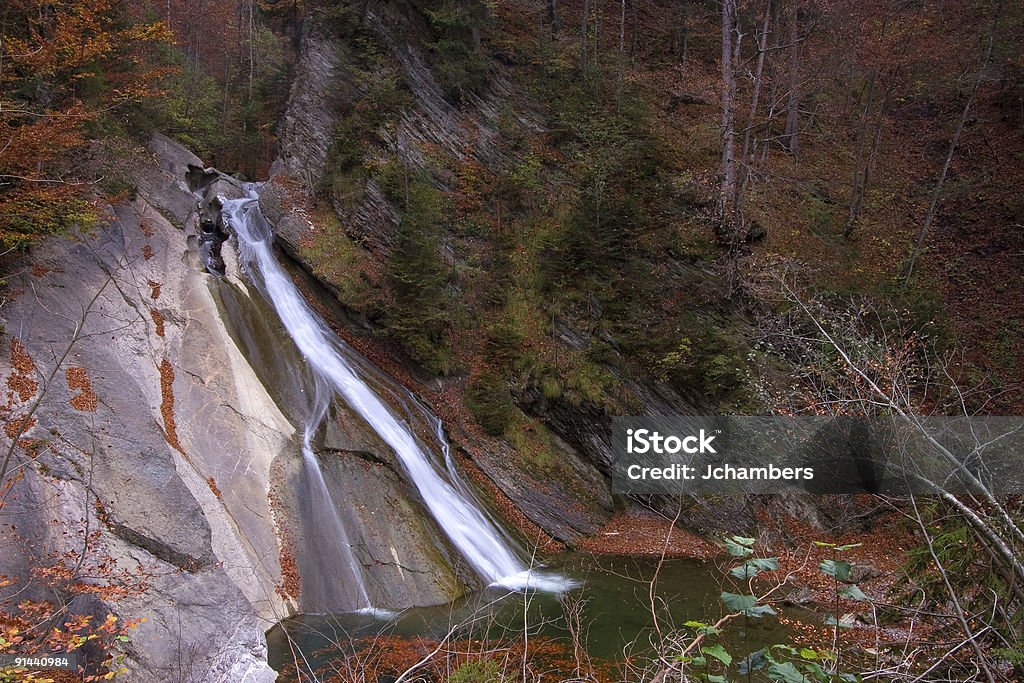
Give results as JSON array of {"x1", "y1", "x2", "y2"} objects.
[{"x1": 223, "y1": 186, "x2": 571, "y2": 596}]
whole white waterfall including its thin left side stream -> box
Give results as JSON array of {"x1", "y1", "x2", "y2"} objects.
[{"x1": 223, "y1": 185, "x2": 569, "y2": 608}]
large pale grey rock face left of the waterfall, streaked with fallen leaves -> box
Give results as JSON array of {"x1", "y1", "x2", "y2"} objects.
[{"x1": 0, "y1": 136, "x2": 284, "y2": 683}]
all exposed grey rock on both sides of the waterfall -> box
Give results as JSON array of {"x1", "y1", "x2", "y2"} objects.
[{"x1": 0, "y1": 3, "x2": 782, "y2": 683}]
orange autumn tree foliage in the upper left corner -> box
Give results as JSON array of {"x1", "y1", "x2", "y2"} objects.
[{"x1": 0, "y1": 0, "x2": 171, "y2": 249}]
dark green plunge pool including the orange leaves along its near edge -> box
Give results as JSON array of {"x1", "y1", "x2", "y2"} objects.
[{"x1": 267, "y1": 553, "x2": 802, "y2": 683}]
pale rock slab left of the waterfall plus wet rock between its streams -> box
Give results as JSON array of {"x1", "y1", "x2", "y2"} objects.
[{"x1": 0, "y1": 136, "x2": 489, "y2": 683}]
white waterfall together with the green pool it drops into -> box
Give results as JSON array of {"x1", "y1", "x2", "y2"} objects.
[{"x1": 223, "y1": 194, "x2": 787, "y2": 682}]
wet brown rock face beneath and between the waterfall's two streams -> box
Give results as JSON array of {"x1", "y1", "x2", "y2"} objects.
[{"x1": 210, "y1": 262, "x2": 478, "y2": 612}]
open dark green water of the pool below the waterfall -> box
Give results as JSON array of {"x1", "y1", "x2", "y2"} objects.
[{"x1": 267, "y1": 554, "x2": 806, "y2": 671}]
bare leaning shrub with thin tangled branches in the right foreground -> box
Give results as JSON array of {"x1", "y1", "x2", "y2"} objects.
[{"x1": 754, "y1": 266, "x2": 1024, "y2": 683}]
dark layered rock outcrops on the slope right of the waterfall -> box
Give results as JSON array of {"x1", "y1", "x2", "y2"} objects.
[{"x1": 260, "y1": 2, "x2": 711, "y2": 544}]
